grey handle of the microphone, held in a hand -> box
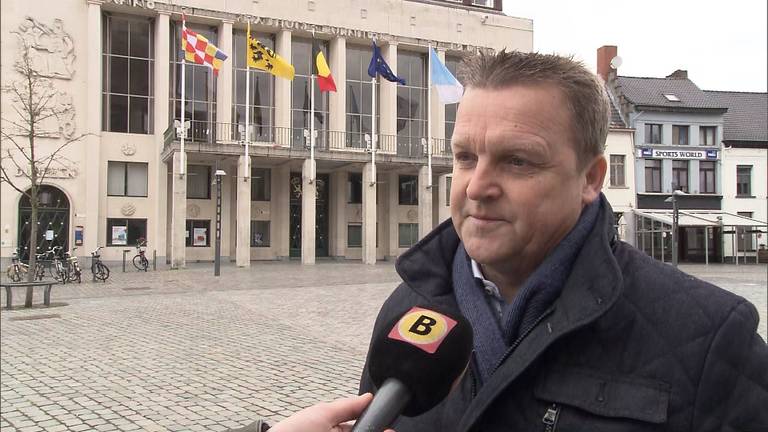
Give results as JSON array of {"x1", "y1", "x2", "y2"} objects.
[{"x1": 352, "y1": 378, "x2": 411, "y2": 432}]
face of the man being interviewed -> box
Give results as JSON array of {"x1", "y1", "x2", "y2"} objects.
[{"x1": 451, "y1": 84, "x2": 602, "y2": 268}]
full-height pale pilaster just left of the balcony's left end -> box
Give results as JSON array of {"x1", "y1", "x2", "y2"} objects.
[{"x1": 154, "y1": 12, "x2": 171, "y2": 263}]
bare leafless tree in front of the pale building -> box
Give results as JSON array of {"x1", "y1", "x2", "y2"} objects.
[{"x1": 0, "y1": 40, "x2": 87, "y2": 294}]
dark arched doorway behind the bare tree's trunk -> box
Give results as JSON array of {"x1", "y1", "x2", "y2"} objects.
[{"x1": 18, "y1": 185, "x2": 69, "y2": 261}]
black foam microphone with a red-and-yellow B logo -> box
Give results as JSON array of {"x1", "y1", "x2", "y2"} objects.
[{"x1": 352, "y1": 306, "x2": 472, "y2": 432}]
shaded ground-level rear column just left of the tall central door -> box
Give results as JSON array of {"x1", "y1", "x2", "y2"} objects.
[{"x1": 270, "y1": 165, "x2": 291, "y2": 260}]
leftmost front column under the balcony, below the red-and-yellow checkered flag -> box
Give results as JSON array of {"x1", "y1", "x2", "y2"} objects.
[{"x1": 171, "y1": 152, "x2": 192, "y2": 269}]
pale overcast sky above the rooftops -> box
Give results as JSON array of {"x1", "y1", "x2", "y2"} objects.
[{"x1": 504, "y1": 0, "x2": 768, "y2": 92}]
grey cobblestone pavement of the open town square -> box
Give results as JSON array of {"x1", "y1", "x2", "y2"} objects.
[{"x1": 0, "y1": 262, "x2": 768, "y2": 432}]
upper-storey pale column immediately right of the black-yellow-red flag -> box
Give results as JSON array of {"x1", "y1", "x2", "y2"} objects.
[{"x1": 328, "y1": 37, "x2": 347, "y2": 148}]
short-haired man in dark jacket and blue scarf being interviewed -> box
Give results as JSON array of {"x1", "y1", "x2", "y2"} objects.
[{"x1": 360, "y1": 51, "x2": 768, "y2": 432}]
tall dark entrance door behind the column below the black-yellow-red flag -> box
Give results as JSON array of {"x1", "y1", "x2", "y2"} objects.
[{"x1": 289, "y1": 172, "x2": 330, "y2": 258}]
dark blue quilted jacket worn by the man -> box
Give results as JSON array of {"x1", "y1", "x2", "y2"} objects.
[{"x1": 360, "y1": 198, "x2": 768, "y2": 432}]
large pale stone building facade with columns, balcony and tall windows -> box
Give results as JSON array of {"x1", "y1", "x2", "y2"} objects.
[{"x1": 0, "y1": 0, "x2": 533, "y2": 268}]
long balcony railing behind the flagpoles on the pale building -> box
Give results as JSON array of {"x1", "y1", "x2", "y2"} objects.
[{"x1": 163, "y1": 121, "x2": 452, "y2": 158}]
